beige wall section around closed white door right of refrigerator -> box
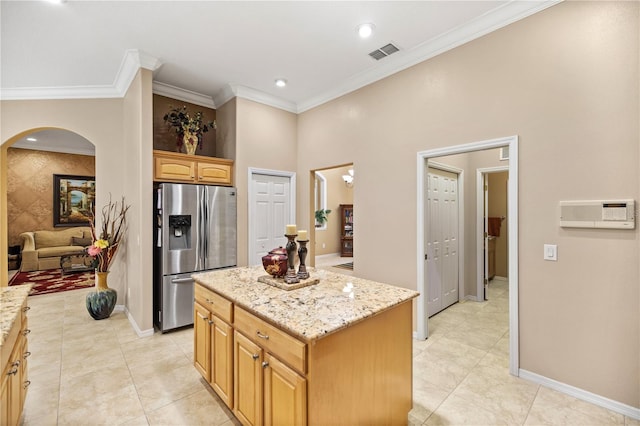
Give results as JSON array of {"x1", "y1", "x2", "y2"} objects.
[{"x1": 232, "y1": 99, "x2": 298, "y2": 266}]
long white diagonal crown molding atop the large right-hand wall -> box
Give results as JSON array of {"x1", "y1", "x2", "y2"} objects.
[{"x1": 296, "y1": 0, "x2": 562, "y2": 113}]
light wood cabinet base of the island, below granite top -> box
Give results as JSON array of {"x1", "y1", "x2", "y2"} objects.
[{"x1": 195, "y1": 283, "x2": 412, "y2": 426}]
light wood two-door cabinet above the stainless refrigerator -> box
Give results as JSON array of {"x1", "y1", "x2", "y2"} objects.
[{"x1": 153, "y1": 150, "x2": 233, "y2": 186}]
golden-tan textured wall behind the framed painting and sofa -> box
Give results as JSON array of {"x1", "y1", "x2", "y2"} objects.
[{"x1": 7, "y1": 148, "x2": 96, "y2": 246}]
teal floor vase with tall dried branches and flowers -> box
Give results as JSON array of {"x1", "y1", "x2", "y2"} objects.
[{"x1": 86, "y1": 196, "x2": 131, "y2": 320}]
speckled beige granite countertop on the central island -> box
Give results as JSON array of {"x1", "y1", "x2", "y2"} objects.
[{"x1": 192, "y1": 266, "x2": 418, "y2": 342}]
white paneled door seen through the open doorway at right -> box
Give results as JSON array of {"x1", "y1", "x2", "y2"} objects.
[{"x1": 425, "y1": 168, "x2": 459, "y2": 316}]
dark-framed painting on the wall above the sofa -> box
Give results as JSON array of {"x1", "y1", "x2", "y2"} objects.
[{"x1": 53, "y1": 175, "x2": 96, "y2": 227}]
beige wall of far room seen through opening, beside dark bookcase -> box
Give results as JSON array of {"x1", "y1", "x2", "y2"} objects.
[{"x1": 316, "y1": 166, "x2": 353, "y2": 256}]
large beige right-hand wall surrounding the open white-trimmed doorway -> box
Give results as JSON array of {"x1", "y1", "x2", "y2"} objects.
[{"x1": 298, "y1": 2, "x2": 640, "y2": 407}]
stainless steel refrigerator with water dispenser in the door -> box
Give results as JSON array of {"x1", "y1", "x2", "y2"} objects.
[{"x1": 153, "y1": 183, "x2": 237, "y2": 333}]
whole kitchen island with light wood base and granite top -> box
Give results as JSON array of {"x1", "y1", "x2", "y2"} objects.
[{"x1": 193, "y1": 267, "x2": 418, "y2": 425}]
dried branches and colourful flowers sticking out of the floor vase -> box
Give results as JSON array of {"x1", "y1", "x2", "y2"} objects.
[{"x1": 87, "y1": 196, "x2": 131, "y2": 272}]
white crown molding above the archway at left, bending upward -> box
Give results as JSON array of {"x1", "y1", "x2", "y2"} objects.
[{"x1": 0, "y1": 49, "x2": 162, "y2": 101}]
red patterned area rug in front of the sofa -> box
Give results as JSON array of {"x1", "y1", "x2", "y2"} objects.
[{"x1": 9, "y1": 269, "x2": 94, "y2": 296}]
